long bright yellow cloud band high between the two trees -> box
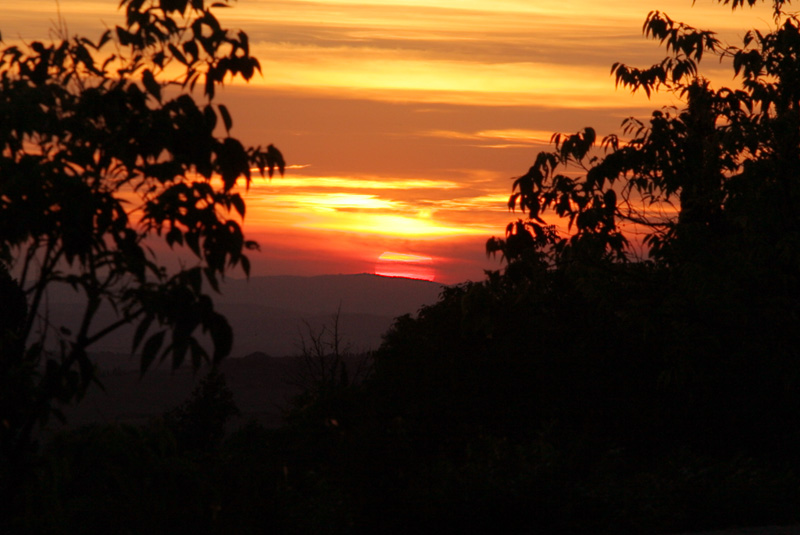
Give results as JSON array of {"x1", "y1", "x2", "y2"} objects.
[{"x1": 250, "y1": 45, "x2": 619, "y2": 108}]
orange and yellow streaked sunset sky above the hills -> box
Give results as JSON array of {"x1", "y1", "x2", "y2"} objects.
[{"x1": 0, "y1": 0, "x2": 772, "y2": 283}]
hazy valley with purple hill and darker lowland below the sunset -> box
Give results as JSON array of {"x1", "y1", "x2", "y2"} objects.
[{"x1": 51, "y1": 274, "x2": 441, "y2": 432}]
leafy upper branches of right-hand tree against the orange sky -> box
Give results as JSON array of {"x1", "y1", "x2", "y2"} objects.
[{"x1": 487, "y1": 1, "x2": 800, "y2": 272}]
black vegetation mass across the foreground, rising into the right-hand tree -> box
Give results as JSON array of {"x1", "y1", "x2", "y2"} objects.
[{"x1": 0, "y1": 0, "x2": 800, "y2": 534}]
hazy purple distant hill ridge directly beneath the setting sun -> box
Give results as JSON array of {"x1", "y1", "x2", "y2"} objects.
[{"x1": 43, "y1": 274, "x2": 442, "y2": 369}]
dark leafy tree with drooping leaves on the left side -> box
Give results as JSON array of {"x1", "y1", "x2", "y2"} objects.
[{"x1": 0, "y1": 0, "x2": 284, "y2": 455}]
